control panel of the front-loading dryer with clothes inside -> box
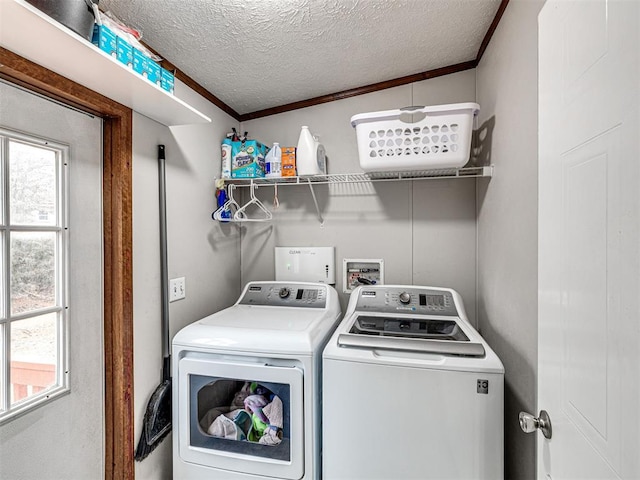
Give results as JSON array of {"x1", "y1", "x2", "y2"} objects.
[{"x1": 238, "y1": 282, "x2": 327, "y2": 308}]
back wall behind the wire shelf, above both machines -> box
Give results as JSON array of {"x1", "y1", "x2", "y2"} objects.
[{"x1": 236, "y1": 70, "x2": 476, "y2": 321}]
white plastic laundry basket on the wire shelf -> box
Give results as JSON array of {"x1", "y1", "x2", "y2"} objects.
[{"x1": 351, "y1": 103, "x2": 480, "y2": 172}]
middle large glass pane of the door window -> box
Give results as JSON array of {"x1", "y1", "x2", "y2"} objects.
[{"x1": 10, "y1": 232, "x2": 56, "y2": 315}]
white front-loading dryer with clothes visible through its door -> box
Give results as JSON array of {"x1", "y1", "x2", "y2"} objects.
[{"x1": 172, "y1": 282, "x2": 341, "y2": 480}]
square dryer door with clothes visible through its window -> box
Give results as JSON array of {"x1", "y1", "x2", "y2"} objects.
[{"x1": 174, "y1": 352, "x2": 304, "y2": 480}]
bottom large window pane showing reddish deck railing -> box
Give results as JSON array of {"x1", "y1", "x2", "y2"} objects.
[{"x1": 10, "y1": 313, "x2": 58, "y2": 405}]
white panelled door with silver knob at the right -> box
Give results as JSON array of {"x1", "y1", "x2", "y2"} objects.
[{"x1": 538, "y1": 0, "x2": 640, "y2": 480}]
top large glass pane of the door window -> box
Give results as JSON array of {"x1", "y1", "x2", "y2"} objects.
[{"x1": 9, "y1": 141, "x2": 57, "y2": 225}]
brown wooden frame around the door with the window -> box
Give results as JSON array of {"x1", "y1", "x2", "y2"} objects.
[{"x1": 0, "y1": 47, "x2": 135, "y2": 480}]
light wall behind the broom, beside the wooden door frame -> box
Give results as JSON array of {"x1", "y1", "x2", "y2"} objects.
[{"x1": 133, "y1": 83, "x2": 240, "y2": 480}]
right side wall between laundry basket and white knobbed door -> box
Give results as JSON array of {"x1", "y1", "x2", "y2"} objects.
[{"x1": 477, "y1": 0, "x2": 544, "y2": 480}]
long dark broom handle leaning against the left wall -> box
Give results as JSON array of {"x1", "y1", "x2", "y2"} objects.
[{"x1": 158, "y1": 145, "x2": 171, "y2": 380}]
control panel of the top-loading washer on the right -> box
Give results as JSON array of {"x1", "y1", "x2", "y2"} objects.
[{"x1": 356, "y1": 285, "x2": 458, "y2": 316}]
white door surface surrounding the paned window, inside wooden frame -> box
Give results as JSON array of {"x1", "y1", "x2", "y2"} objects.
[{"x1": 0, "y1": 82, "x2": 104, "y2": 480}]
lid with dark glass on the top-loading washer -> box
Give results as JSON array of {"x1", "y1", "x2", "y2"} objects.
[{"x1": 337, "y1": 312, "x2": 485, "y2": 357}]
